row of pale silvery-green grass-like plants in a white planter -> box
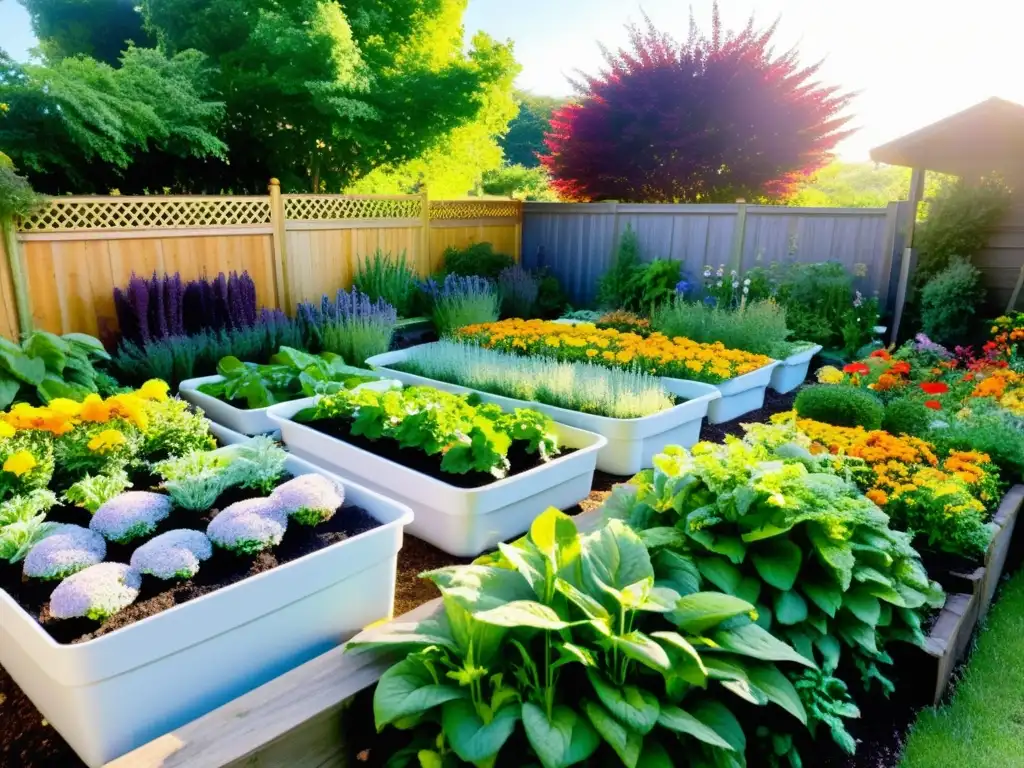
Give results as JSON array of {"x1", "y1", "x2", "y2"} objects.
[{"x1": 396, "y1": 342, "x2": 674, "y2": 419}]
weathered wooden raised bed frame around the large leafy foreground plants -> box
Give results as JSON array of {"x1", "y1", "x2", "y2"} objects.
[{"x1": 106, "y1": 484, "x2": 1024, "y2": 768}]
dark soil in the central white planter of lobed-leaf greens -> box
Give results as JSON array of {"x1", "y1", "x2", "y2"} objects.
[{"x1": 306, "y1": 418, "x2": 575, "y2": 488}]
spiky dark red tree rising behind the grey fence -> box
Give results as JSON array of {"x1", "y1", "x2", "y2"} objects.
[{"x1": 541, "y1": 3, "x2": 850, "y2": 202}]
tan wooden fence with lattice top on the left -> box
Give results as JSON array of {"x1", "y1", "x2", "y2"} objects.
[{"x1": 0, "y1": 180, "x2": 521, "y2": 338}]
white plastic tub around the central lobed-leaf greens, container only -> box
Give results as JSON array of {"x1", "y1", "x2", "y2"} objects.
[{"x1": 269, "y1": 398, "x2": 607, "y2": 557}]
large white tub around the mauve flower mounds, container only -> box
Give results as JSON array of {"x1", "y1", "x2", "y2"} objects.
[{"x1": 0, "y1": 426, "x2": 413, "y2": 768}]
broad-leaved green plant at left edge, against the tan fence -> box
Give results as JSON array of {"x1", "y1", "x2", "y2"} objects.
[{"x1": 0, "y1": 331, "x2": 117, "y2": 410}]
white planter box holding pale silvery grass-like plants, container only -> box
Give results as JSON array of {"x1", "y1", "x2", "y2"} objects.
[{"x1": 367, "y1": 345, "x2": 722, "y2": 475}]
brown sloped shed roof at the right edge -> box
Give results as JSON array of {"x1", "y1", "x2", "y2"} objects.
[{"x1": 871, "y1": 97, "x2": 1024, "y2": 182}]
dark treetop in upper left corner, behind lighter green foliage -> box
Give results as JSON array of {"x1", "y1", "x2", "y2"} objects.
[{"x1": 18, "y1": 0, "x2": 155, "y2": 67}]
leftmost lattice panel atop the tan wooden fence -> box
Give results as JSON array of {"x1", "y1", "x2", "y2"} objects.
[{"x1": 18, "y1": 197, "x2": 270, "y2": 232}]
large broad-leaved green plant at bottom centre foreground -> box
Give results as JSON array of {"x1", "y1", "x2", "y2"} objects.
[{"x1": 350, "y1": 509, "x2": 813, "y2": 768}]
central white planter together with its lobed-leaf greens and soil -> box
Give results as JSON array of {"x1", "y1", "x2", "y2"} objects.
[{"x1": 270, "y1": 387, "x2": 605, "y2": 556}]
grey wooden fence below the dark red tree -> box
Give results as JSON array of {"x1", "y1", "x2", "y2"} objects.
[{"x1": 522, "y1": 203, "x2": 898, "y2": 303}]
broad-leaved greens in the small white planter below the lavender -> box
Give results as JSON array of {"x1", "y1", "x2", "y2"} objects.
[{"x1": 199, "y1": 347, "x2": 378, "y2": 409}]
